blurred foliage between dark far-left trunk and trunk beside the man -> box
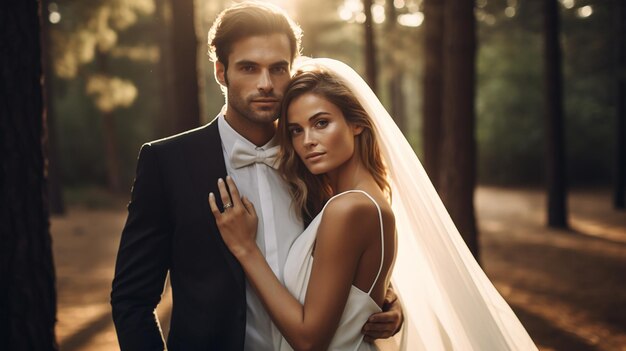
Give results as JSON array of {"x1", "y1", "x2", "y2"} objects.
[{"x1": 51, "y1": 0, "x2": 161, "y2": 190}]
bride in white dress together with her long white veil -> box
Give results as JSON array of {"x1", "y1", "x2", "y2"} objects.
[{"x1": 209, "y1": 59, "x2": 537, "y2": 351}]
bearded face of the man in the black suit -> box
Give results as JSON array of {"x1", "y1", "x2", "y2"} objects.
[{"x1": 216, "y1": 34, "x2": 291, "y2": 124}]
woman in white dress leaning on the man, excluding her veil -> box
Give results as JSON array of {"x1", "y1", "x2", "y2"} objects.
[{"x1": 210, "y1": 62, "x2": 396, "y2": 350}]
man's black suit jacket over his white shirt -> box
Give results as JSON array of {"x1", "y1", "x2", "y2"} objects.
[{"x1": 111, "y1": 121, "x2": 246, "y2": 351}]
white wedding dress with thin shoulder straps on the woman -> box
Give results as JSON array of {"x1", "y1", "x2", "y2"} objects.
[{"x1": 280, "y1": 190, "x2": 385, "y2": 351}]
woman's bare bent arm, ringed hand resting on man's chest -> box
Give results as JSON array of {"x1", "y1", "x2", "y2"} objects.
[{"x1": 209, "y1": 178, "x2": 380, "y2": 350}]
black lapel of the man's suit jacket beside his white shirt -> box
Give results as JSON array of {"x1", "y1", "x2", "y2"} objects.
[{"x1": 187, "y1": 118, "x2": 245, "y2": 288}]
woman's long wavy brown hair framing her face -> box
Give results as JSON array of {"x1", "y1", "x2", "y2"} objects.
[{"x1": 278, "y1": 67, "x2": 391, "y2": 223}]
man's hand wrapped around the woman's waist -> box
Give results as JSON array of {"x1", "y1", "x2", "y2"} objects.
[{"x1": 362, "y1": 287, "x2": 404, "y2": 343}]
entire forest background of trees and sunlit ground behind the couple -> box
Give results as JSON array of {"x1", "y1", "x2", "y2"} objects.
[{"x1": 0, "y1": 0, "x2": 626, "y2": 351}]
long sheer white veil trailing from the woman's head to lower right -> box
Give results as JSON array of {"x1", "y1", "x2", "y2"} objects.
[{"x1": 296, "y1": 58, "x2": 537, "y2": 351}]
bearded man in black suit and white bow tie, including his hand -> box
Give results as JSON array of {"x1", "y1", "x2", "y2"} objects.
[{"x1": 111, "y1": 3, "x2": 402, "y2": 351}]
